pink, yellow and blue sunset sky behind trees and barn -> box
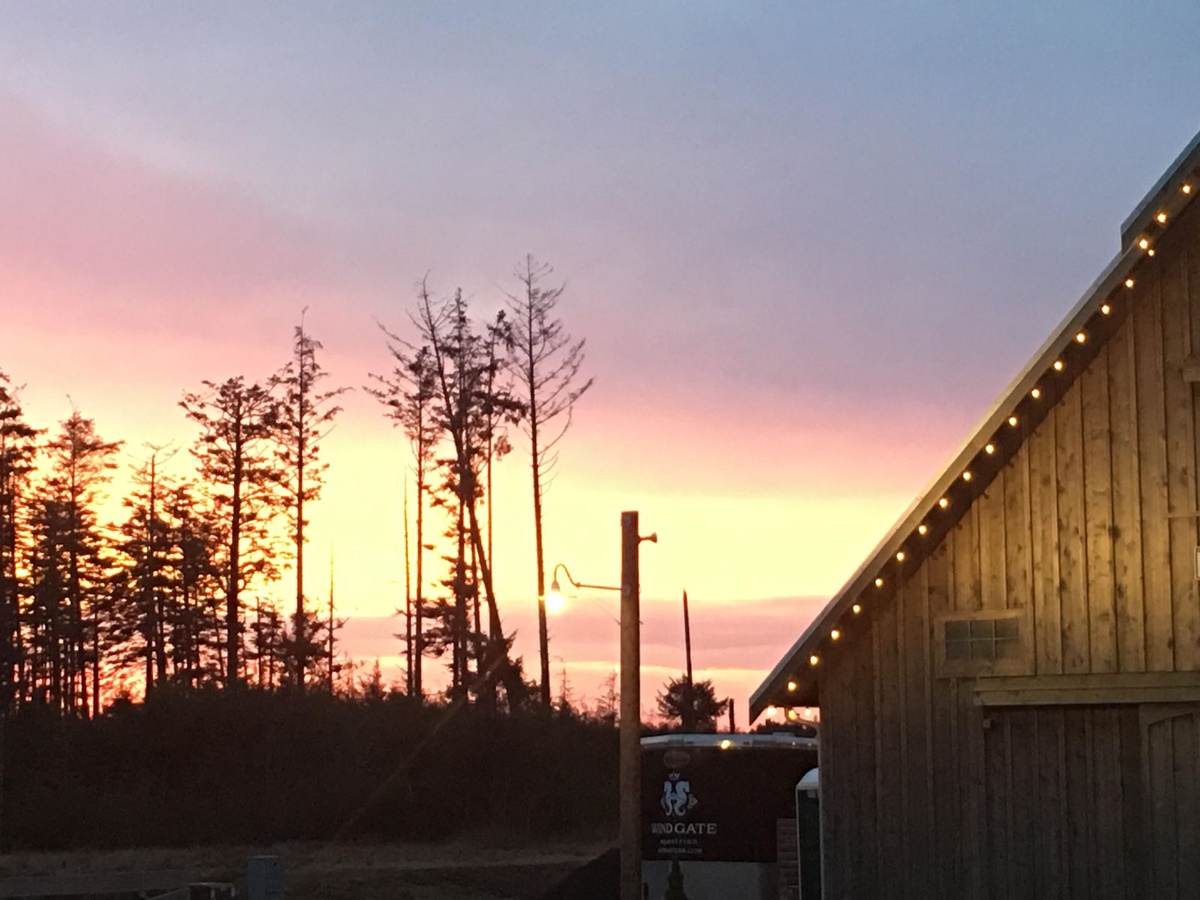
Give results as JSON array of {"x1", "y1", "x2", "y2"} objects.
[{"x1": 0, "y1": 0, "x2": 1200, "y2": 725}]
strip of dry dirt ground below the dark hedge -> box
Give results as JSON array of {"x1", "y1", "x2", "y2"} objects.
[{"x1": 0, "y1": 839, "x2": 611, "y2": 900}]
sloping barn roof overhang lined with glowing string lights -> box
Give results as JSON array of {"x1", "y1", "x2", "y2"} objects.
[{"x1": 750, "y1": 134, "x2": 1200, "y2": 721}]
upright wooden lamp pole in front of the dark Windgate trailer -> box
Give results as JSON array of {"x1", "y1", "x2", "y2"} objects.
[{"x1": 619, "y1": 512, "x2": 642, "y2": 900}]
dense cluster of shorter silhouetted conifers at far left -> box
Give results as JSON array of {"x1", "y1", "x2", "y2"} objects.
[{"x1": 0, "y1": 324, "x2": 338, "y2": 716}]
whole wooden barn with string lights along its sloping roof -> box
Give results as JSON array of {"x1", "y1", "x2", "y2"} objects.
[{"x1": 751, "y1": 128, "x2": 1200, "y2": 900}]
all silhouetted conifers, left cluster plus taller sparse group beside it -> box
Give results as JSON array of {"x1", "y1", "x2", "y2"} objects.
[{"x1": 0, "y1": 257, "x2": 590, "y2": 716}]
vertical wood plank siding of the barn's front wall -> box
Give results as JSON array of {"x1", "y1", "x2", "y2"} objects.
[{"x1": 821, "y1": 196, "x2": 1200, "y2": 900}]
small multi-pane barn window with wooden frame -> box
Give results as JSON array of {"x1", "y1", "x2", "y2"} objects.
[{"x1": 937, "y1": 610, "x2": 1030, "y2": 677}]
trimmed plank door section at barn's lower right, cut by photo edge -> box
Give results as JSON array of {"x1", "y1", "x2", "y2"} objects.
[{"x1": 1140, "y1": 703, "x2": 1200, "y2": 900}]
